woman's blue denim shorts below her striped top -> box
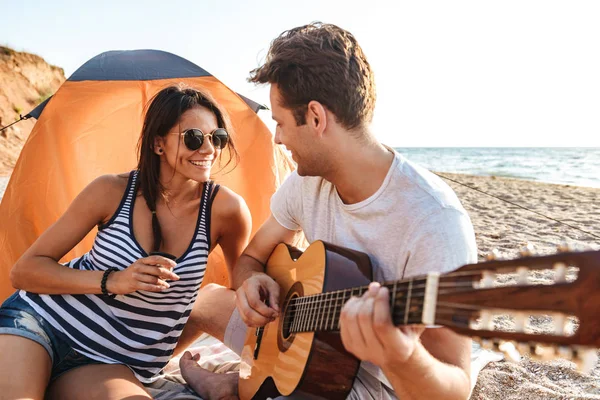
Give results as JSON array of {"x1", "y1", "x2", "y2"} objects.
[{"x1": 0, "y1": 292, "x2": 102, "y2": 381}]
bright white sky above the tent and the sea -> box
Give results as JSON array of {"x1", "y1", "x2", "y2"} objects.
[{"x1": 0, "y1": 0, "x2": 600, "y2": 147}]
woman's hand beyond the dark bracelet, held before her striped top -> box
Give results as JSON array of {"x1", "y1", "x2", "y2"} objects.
[{"x1": 106, "y1": 256, "x2": 179, "y2": 294}]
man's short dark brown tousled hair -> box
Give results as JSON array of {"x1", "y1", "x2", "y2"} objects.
[{"x1": 248, "y1": 22, "x2": 376, "y2": 129}]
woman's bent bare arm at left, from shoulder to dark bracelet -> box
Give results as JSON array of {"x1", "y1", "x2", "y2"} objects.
[{"x1": 10, "y1": 175, "x2": 127, "y2": 294}]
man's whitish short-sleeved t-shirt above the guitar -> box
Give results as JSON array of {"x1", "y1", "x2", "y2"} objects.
[{"x1": 271, "y1": 152, "x2": 477, "y2": 386}]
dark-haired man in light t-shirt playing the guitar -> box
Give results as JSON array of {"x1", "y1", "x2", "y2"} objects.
[{"x1": 182, "y1": 23, "x2": 476, "y2": 400}]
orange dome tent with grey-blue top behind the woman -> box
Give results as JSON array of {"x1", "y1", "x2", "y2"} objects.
[{"x1": 0, "y1": 50, "x2": 293, "y2": 300}]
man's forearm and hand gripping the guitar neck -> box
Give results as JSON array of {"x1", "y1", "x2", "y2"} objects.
[{"x1": 340, "y1": 283, "x2": 471, "y2": 400}]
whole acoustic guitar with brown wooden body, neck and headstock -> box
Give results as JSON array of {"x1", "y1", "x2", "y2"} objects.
[{"x1": 239, "y1": 241, "x2": 600, "y2": 400}]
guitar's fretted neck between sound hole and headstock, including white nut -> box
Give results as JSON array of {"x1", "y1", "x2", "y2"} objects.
[{"x1": 284, "y1": 274, "x2": 439, "y2": 333}]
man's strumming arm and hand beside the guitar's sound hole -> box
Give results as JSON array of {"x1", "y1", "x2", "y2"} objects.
[{"x1": 231, "y1": 215, "x2": 296, "y2": 326}]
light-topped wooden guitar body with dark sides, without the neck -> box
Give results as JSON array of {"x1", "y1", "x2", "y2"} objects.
[{"x1": 239, "y1": 241, "x2": 372, "y2": 400}]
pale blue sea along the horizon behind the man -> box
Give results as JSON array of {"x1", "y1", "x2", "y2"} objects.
[{"x1": 396, "y1": 147, "x2": 600, "y2": 188}]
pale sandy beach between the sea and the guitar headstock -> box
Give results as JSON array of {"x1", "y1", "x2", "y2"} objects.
[{"x1": 0, "y1": 173, "x2": 600, "y2": 400}]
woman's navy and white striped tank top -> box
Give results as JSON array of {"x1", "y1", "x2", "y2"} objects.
[{"x1": 20, "y1": 171, "x2": 219, "y2": 383}]
